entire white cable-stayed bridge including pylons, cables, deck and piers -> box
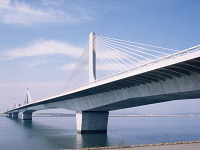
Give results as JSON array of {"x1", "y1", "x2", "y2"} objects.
[{"x1": 6, "y1": 32, "x2": 200, "y2": 133}]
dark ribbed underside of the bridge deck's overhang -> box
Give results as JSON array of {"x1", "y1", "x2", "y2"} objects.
[{"x1": 44, "y1": 58, "x2": 200, "y2": 103}]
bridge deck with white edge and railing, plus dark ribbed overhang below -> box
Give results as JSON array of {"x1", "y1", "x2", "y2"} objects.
[{"x1": 5, "y1": 46, "x2": 200, "y2": 112}]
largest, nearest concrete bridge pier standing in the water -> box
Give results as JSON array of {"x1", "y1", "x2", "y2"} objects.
[{"x1": 76, "y1": 111, "x2": 109, "y2": 133}]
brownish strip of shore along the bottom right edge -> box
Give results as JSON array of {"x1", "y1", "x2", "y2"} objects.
[{"x1": 69, "y1": 141, "x2": 200, "y2": 150}]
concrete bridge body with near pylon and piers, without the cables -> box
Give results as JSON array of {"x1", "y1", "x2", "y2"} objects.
[{"x1": 6, "y1": 33, "x2": 200, "y2": 133}]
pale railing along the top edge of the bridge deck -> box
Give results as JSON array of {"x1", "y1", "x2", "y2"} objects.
[{"x1": 69, "y1": 45, "x2": 200, "y2": 91}]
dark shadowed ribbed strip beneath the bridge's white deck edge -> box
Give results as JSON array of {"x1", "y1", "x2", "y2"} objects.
[{"x1": 5, "y1": 50, "x2": 200, "y2": 110}]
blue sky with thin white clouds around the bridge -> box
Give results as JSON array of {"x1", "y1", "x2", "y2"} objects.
[{"x1": 0, "y1": 0, "x2": 200, "y2": 114}]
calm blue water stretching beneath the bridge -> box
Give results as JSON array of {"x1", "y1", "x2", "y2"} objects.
[{"x1": 0, "y1": 117, "x2": 200, "y2": 150}]
